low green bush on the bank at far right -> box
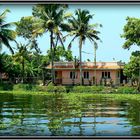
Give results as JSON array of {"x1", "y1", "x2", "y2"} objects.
[{"x1": 117, "y1": 86, "x2": 137, "y2": 94}]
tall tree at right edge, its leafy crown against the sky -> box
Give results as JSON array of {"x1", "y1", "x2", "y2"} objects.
[{"x1": 121, "y1": 17, "x2": 140, "y2": 90}]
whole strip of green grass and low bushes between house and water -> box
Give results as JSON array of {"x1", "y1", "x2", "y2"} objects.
[{"x1": 0, "y1": 84, "x2": 140, "y2": 102}]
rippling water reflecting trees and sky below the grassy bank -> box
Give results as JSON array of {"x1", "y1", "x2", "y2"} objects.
[{"x1": 0, "y1": 94, "x2": 140, "y2": 136}]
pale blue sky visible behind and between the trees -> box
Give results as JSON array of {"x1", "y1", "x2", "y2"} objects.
[{"x1": 0, "y1": 4, "x2": 140, "y2": 63}]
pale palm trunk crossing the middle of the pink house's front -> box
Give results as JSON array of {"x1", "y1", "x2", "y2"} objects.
[{"x1": 79, "y1": 37, "x2": 83, "y2": 85}]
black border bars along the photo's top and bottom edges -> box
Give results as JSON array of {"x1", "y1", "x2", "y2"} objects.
[{"x1": 0, "y1": 0, "x2": 140, "y2": 140}]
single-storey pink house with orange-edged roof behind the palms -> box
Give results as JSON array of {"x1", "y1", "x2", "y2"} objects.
[{"x1": 47, "y1": 62, "x2": 125, "y2": 85}]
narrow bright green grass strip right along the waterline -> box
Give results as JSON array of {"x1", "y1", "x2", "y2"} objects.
[{"x1": 0, "y1": 91, "x2": 140, "y2": 102}]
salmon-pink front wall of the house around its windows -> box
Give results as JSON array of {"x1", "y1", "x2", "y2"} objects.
[{"x1": 62, "y1": 70, "x2": 117, "y2": 84}]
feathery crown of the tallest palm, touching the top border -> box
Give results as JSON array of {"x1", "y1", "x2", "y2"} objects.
[{"x1": 32, "y1": 4, "x2": 70, "y2": 35}]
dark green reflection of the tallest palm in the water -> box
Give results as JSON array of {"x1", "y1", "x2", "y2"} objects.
[{"x1": 47, "y1": 95, "x2": 68, "y2": 136}]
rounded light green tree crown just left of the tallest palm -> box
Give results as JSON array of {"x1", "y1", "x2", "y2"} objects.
[{"x1": 15, "y1": 16, "x2": 44, "y2": 53}]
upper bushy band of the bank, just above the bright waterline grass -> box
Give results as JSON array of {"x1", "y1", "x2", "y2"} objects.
[{"x1": 0, "y1": 83, "x2": 139, "y2": 94}]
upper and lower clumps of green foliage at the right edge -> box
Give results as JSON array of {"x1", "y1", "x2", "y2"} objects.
[{"x1": 121, "y1": 17, "x2": 140, "y2": 91}]
